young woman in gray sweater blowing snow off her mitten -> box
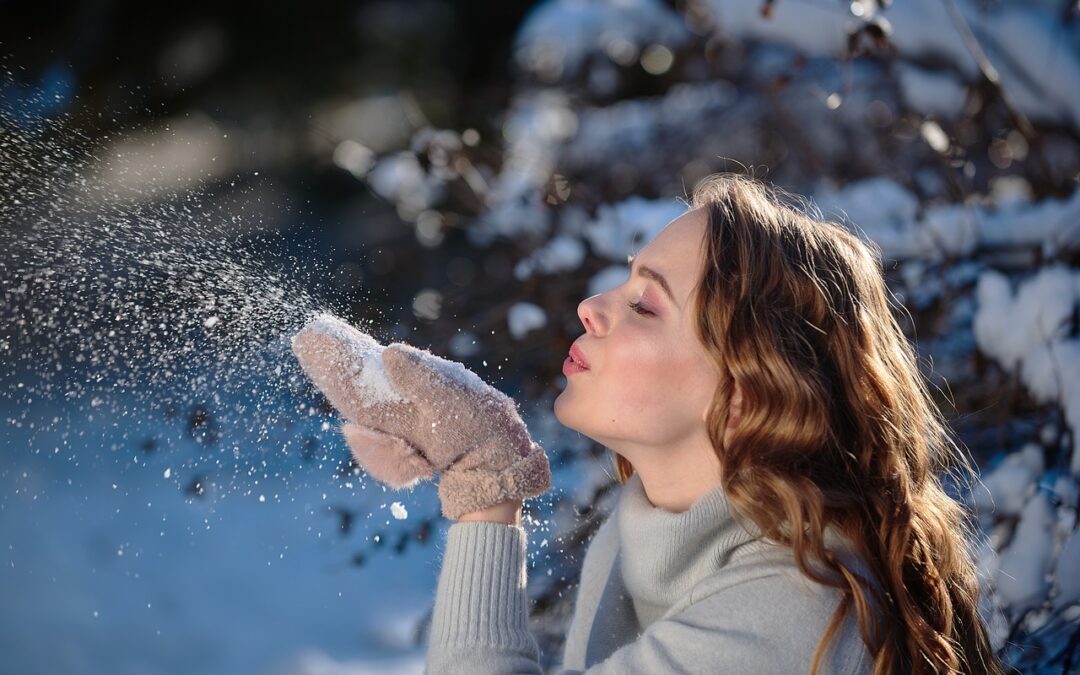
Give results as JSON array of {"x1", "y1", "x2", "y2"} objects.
[{"x1": 294, "y1": 170, "x2": 1002, "y2": 674}]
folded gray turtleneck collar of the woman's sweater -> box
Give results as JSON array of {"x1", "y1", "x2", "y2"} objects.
[{"x1": 616, "y1": 473, "x2": 759, "y2": 620}]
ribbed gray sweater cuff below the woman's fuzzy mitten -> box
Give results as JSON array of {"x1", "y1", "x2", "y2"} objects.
[{"x1": 430, "y1": 521, "x2": 537, "y2": 652}]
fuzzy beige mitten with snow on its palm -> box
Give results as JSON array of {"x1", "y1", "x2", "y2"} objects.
[{"x1": 293, "y1": 314, "x2": 551, "y2": 519}]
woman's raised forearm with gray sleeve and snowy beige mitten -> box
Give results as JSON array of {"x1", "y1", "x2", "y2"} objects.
[{"x1": 293, "y1": 315, "x2": 551, "y2": 673}]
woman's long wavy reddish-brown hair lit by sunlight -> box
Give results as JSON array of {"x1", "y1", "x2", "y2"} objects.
[{"x1": 616, "y1": 174, "x2": 1003, "y2": 675}]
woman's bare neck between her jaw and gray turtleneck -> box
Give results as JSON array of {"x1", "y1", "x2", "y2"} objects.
[{"x1": 616, "y1": 436, "x2": 720, "y2": 513}]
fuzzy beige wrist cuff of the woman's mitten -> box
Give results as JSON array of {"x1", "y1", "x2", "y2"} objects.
[{"x1": 438, "y1": 443, "x2": 551, "y2": 521}]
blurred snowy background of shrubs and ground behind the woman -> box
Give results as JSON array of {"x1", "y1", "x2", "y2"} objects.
[{"x1": 0, "y1": 0, "x2": 1080, "y2": 675}]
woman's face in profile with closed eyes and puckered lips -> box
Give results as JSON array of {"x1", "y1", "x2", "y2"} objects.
[{"x1": 555, "y1": 210, "x2": 719, "y2": 461}]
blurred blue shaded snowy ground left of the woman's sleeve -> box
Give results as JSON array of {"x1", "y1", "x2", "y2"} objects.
[{"x1": 0, "y1": 384, "x2": 442, "y2": 675}]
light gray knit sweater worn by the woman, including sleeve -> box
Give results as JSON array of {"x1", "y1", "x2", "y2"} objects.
[{"x1": 427, "y1": 474, "x2": 872, "y2": 675}]
